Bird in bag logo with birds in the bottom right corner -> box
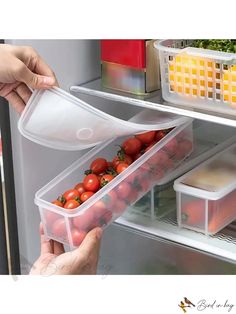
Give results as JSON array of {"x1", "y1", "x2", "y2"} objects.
[{"x1": 178, "y1": 297, "x2": 235, "y2": 313}]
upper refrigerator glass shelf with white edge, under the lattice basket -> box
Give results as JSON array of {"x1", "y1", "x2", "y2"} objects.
[{"x1": 70, "y1": 78, "x2": 236, "y2": 127}]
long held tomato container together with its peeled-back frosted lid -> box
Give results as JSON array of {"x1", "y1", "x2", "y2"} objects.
[{"x1": 19, "y1": 88, "x2": 193, "y2": 248}]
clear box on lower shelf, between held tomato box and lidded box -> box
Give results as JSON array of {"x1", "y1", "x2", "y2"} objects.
[{"x1": 128, "y1": 121, "x2": 236, "y2": 220}]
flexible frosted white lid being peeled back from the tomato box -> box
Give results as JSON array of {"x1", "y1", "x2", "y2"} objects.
[{"x1": 18, "y1": 87, "x2": 189, "y2": 150}]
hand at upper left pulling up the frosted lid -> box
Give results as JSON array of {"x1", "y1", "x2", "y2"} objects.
[{"x1": 0, "y1": 44, "x2": 58, "y2": 113}]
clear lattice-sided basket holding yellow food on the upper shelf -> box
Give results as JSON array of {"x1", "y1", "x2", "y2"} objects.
[{"x1": 154, "y1": 40, "x2": 236, "y2": 114}]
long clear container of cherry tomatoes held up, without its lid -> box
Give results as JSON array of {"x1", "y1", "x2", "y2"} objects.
[{"x1": 35, "y1": 120, "x2": 193, "y2": 248}]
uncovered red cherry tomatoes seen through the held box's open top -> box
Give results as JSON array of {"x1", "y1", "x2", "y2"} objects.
[{"x1": 52, "y1": 130, "x2": 169, "y2": 210}]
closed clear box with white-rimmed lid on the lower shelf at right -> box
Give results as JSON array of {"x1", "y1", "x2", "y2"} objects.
[{"x1": 174, "y1": 144, "x2": 236, "y2": 235}]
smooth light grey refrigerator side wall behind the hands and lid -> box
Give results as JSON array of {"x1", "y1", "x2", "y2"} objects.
[{"x1": 7, "y1": 40, "x2": 100, "y2": 274}]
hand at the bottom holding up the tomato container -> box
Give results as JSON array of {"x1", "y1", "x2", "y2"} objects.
[{"x1": 30, "y1": 224, "x2": 102, "y2": 276}]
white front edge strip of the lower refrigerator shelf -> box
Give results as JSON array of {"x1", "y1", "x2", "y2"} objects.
[{"x1": 115, "y1": 214, "x2": 236, "y2": 264}]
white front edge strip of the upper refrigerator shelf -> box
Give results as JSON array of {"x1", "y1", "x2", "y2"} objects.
[{"x1": 70, "y1": 84, "x2": 236, "y2": 127}]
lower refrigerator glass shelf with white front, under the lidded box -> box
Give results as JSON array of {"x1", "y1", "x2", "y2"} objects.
[{"x1": 114, "y1": 211, "x2": 236, "y2": 265}]
